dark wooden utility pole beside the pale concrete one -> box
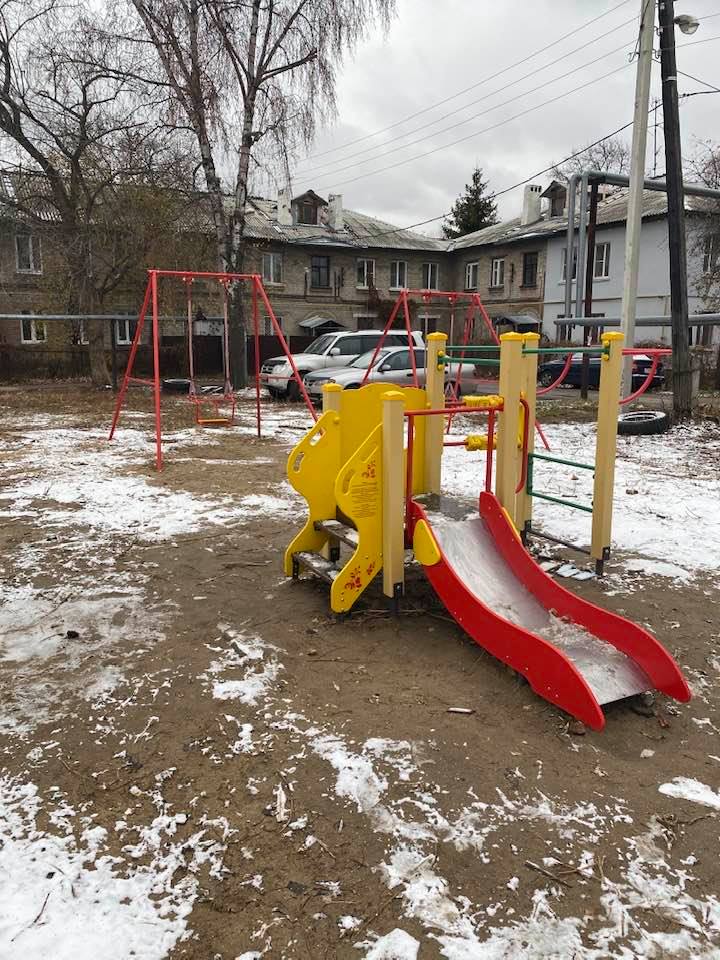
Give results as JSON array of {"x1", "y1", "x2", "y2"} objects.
[{"x1": 660, "y1": 0, "x2": 692, "y2": 421}]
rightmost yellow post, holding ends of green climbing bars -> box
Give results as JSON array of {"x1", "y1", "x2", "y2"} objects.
[{"x1": 590, "y1": 333, "x2": 623, "y2": 573}]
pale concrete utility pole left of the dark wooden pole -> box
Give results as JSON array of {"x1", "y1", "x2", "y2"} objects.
[{"x1": 620, "y1": 0, "x2": 655, "y2": 394}]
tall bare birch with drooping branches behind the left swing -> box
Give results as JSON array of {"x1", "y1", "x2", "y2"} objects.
[{"x1": 121, "y1": 0, "x2": 395, "y2": 386}]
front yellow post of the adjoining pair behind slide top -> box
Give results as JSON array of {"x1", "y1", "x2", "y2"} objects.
[{"x1": 495, "y1": 333, "x2": 523, "y2": 527}]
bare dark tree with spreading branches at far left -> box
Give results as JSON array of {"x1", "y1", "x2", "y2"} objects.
[{"x1": 0, "y1": 0, "x2": 191, "y2": 385}]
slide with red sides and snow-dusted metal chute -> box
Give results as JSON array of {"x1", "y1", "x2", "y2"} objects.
[{"x1": 415, "y1": 494, "x2": 690, "y2": 729}]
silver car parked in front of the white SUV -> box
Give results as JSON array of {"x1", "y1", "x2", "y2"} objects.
[{"x1": 304, "y1": 344, "x2": 473, "y2": 402}]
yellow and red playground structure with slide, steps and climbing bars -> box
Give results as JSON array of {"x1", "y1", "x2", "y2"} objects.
[{"x1": 285, "y1": 334, "x2": 690, "y2": 729}]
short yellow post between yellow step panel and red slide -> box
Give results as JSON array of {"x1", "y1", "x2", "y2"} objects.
[{"x1": 382, "y1": 390, "x2": 405, "y2": 603}]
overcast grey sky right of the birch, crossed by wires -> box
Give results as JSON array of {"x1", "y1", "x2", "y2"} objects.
[{"x1": 284, "y1": 0, "x2": 720, "y2": 233}]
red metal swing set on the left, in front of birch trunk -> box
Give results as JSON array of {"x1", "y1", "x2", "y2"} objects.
[{"x1": 108, "y1": 270, "x2": 317, "y2": 470}]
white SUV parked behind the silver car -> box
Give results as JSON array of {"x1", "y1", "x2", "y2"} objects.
[{"x1": 262, "y1": 330, "x2": 423, "y2": 400}]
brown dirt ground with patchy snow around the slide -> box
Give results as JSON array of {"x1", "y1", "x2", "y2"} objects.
[{"x1": 0, "y1": 387, "x2": 720, "y2": 960}]
